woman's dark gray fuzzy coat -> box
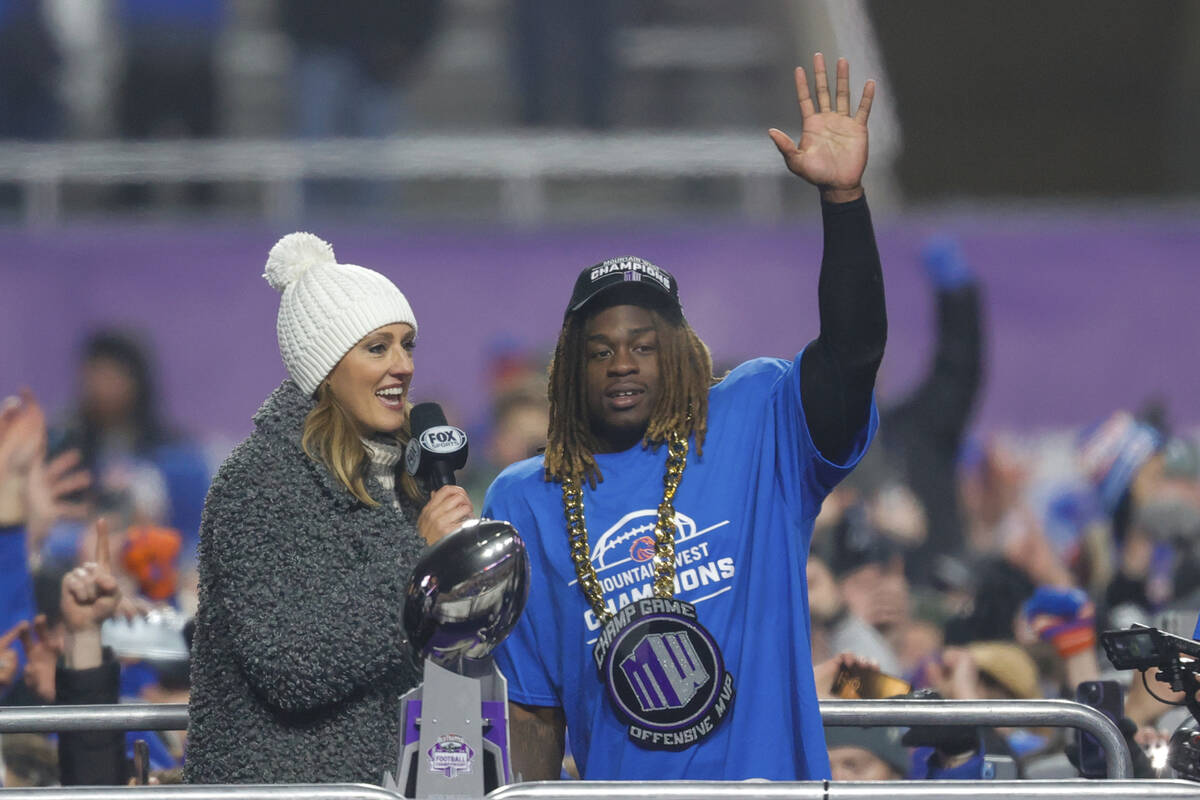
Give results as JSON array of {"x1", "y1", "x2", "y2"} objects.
[{"x1": 185, "y1": 380, "x2": 424, "y2": 783}]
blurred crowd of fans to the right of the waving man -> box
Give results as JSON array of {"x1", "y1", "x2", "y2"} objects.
[{"x1": 808, "y1": 241, "x2": 1200, "y2": 780}]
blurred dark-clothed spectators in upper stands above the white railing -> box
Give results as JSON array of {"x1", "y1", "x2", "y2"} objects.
[{"x1": 0, "y1": 0, "x2": 614, "y2": 140}]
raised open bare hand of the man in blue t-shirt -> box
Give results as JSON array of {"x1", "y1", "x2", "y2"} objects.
[{"x1": 768, "y1": 53, "x2": 875, "y2": 203}]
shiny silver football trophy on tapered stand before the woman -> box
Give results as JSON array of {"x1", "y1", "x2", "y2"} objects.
[{"x1": 384, "y1": 519, "x2": 529, "y2": 798}]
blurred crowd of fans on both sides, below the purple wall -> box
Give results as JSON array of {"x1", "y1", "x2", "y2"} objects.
[{"x1": 0, "y1": 235, "x2": 1200, "y2": 786}]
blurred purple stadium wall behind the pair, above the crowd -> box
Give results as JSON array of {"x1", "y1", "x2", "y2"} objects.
[{"x1": 0, "y1": 215, "x2": 1200, "y2": 450}]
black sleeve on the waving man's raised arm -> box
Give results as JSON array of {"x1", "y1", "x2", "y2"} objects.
[{"x1": 800, "y1": 197, "x2": 888, "y2": 463}]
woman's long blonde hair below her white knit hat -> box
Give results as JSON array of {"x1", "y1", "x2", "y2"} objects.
[{"x1": 300, "y1": 383, "x2": 425, "y2": 506}]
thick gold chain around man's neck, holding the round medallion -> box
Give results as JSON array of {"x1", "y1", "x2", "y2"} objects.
[{"x1": 563, "y1": 431, "x2": 688, "y2": 622}]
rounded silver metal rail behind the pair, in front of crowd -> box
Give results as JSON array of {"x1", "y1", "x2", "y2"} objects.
[{"x1": 0, "y1": 699, "x2": 1133, "y2": 780}]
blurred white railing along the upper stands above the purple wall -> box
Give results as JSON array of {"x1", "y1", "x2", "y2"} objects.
[{"x1": 0, "y1": 131, "x2": 786, "y2": 225}]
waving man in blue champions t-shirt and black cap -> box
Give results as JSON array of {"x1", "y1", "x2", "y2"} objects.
[{"x1": 484, "y1": 54, "x2": 887, "y2": 781}]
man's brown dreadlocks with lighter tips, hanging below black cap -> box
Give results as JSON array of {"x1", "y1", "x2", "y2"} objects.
[{"x1": 545, "y1": 302, "x2": 716, "y2": 488}]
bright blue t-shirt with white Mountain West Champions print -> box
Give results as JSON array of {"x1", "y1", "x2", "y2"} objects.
[{"x1": 484, "y1": 356, "x2": 878, "y2": 780}]
